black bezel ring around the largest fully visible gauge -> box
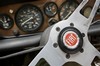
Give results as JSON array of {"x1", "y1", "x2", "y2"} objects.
[{"x1": 15, "y1": 3, "x2": 44, "y2": 33}]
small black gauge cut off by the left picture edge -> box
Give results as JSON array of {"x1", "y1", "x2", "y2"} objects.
[{"x1": 0, "y1": 14, "x2": 14, "y2": 30}]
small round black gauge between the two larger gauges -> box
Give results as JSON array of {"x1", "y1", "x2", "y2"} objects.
[{"x1": 44, "y1": 2, "x2": 58, "y2": 17}]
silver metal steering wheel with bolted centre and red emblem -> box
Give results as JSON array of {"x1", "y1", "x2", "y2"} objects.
[{"x1": 29, "y1": 0, "x2": 100, "y2": 66}]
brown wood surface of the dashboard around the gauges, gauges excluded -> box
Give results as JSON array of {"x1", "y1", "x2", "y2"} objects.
[{"x1": 0, "y1": 0, "x2": 100, "y2": 36}]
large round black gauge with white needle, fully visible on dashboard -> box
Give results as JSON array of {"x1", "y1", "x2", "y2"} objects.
[{"x1": 15, "y1": 4, "x2": 43, "y2": 32}]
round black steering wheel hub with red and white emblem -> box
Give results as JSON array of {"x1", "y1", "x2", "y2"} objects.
[{"x1": 58, "y1": 27, "x2": 83, "y2": 54}]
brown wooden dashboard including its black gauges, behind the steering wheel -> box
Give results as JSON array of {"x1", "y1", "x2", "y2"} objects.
[{"x1": 0, "y1": 0, "x2": 100, "y2": 36}]
